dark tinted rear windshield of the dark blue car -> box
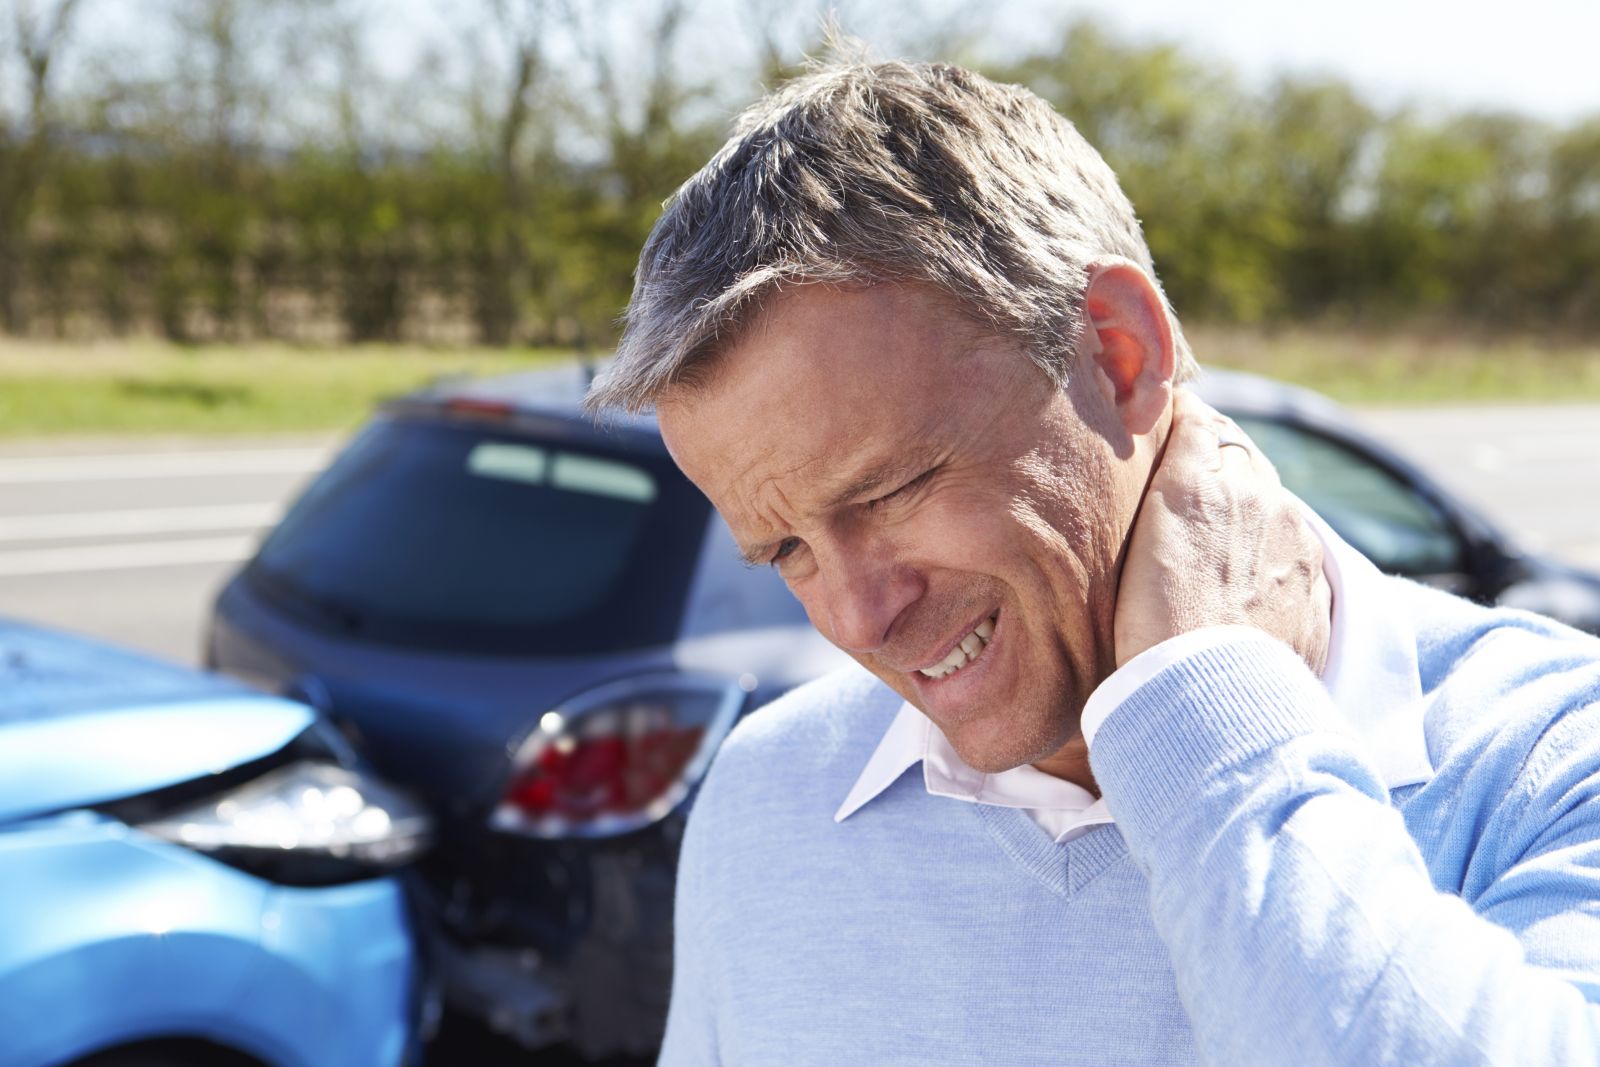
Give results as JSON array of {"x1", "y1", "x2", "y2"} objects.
[{"x1": 248, "y1": 418, "x2": 710, "y2": 654}]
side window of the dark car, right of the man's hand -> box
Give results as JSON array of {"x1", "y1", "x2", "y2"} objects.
[{"x1": 1234, "y1": 414, "x2": 1462, "y2": 576}]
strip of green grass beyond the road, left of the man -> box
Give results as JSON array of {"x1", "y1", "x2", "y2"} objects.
[{"x1": 0, "y1": 341, "x2": 573, "y2": 437}]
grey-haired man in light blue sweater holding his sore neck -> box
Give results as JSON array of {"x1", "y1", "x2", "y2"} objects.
[{"x1": 592, "y1": 64, "x2": 1600, "y2": 1067}]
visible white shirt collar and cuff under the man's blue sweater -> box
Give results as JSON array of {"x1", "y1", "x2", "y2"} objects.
[{"x1": 834, "y1": 509, "x2": 1434, "y2": 841}]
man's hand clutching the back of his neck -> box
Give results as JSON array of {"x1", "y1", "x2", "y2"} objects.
[{"x1": 1115, "y1": 389, "x2": 1333, "y2": 673}]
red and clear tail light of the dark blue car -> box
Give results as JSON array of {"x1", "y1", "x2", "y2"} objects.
[{"x1": 493, "y1": 673, "x2": 744, "y2": 837}]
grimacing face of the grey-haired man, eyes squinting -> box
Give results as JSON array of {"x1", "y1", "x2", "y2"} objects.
[{"x1": 658, "y1": 285, "x2": 1149, "y2": 773}]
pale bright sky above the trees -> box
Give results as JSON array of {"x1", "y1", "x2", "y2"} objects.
[{"x1": 34, "y1": 0, "x2": 1600, "y2": 123}]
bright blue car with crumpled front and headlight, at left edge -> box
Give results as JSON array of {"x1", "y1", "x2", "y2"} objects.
[{"x1": 0, "y1": 621, "x2": 430, "y2": 1067}]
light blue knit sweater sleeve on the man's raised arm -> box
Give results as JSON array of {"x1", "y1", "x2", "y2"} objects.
[{"x1": 1090, "y1": 635, "x2": 1600, "y2": 1065}]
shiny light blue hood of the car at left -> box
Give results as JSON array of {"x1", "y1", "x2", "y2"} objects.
[{"x1": 0, "y1": 621, "x2": 315, "y2": 821}]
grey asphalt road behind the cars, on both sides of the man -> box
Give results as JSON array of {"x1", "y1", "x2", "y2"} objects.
[{"x1": 0, "y1": 405, "x2": 1600, "y2": 662}]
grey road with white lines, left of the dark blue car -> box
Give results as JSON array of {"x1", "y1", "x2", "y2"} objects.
[{"x1": 0, "y1": 437, "x2": 336, "y2": 662}]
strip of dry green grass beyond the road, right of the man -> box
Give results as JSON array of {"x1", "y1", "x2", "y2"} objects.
[{"x1": 1187, "y1": 326, "x2": 1600, "y2": 405}]
